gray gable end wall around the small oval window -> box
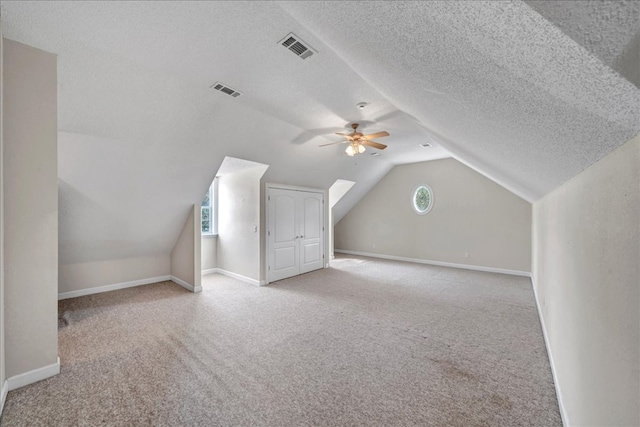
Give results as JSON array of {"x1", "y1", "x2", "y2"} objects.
[{"x1": 334, "y1": 159, "x2": 531, "y2": 272}]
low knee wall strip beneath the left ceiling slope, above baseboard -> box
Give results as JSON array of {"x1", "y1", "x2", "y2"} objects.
[{"x1": 58, "y1": 255, "x2": 171, "y2": 293}]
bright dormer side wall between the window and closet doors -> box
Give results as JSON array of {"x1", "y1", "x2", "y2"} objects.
[{"x1": 217, "y1": 166, "x2": 267, "y2": 281}]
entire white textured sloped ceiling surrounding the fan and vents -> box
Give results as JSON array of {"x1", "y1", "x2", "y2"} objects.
[{"x1": 1, "y1": 1, "x2": 640, "y2": 263}]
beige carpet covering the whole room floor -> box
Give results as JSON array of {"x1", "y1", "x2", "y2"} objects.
[{"x1": 1, "y1": 257, "x2": 561, "y2": 426}]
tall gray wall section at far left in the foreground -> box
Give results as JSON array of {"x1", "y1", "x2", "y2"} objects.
[{"x1": 2, "y1": 40, "x2": 58, "y2": 377}]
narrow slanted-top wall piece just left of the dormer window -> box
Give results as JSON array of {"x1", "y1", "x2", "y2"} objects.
[{"x1": 171, "y1": 204, "x2": 202, "y2": 291}]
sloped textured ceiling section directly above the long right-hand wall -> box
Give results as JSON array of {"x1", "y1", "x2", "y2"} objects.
[{"x1": 284, "y1": 1, "x2": 640, "y2": 200}]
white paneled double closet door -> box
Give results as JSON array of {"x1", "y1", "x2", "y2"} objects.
[{"x1": 267, "y1": 187, "x2": 324, "y2": 282}]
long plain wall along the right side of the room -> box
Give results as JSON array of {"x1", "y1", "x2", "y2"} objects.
[{"x1": 533, "y1": 135, "x2": 640, "y2": 426}]
